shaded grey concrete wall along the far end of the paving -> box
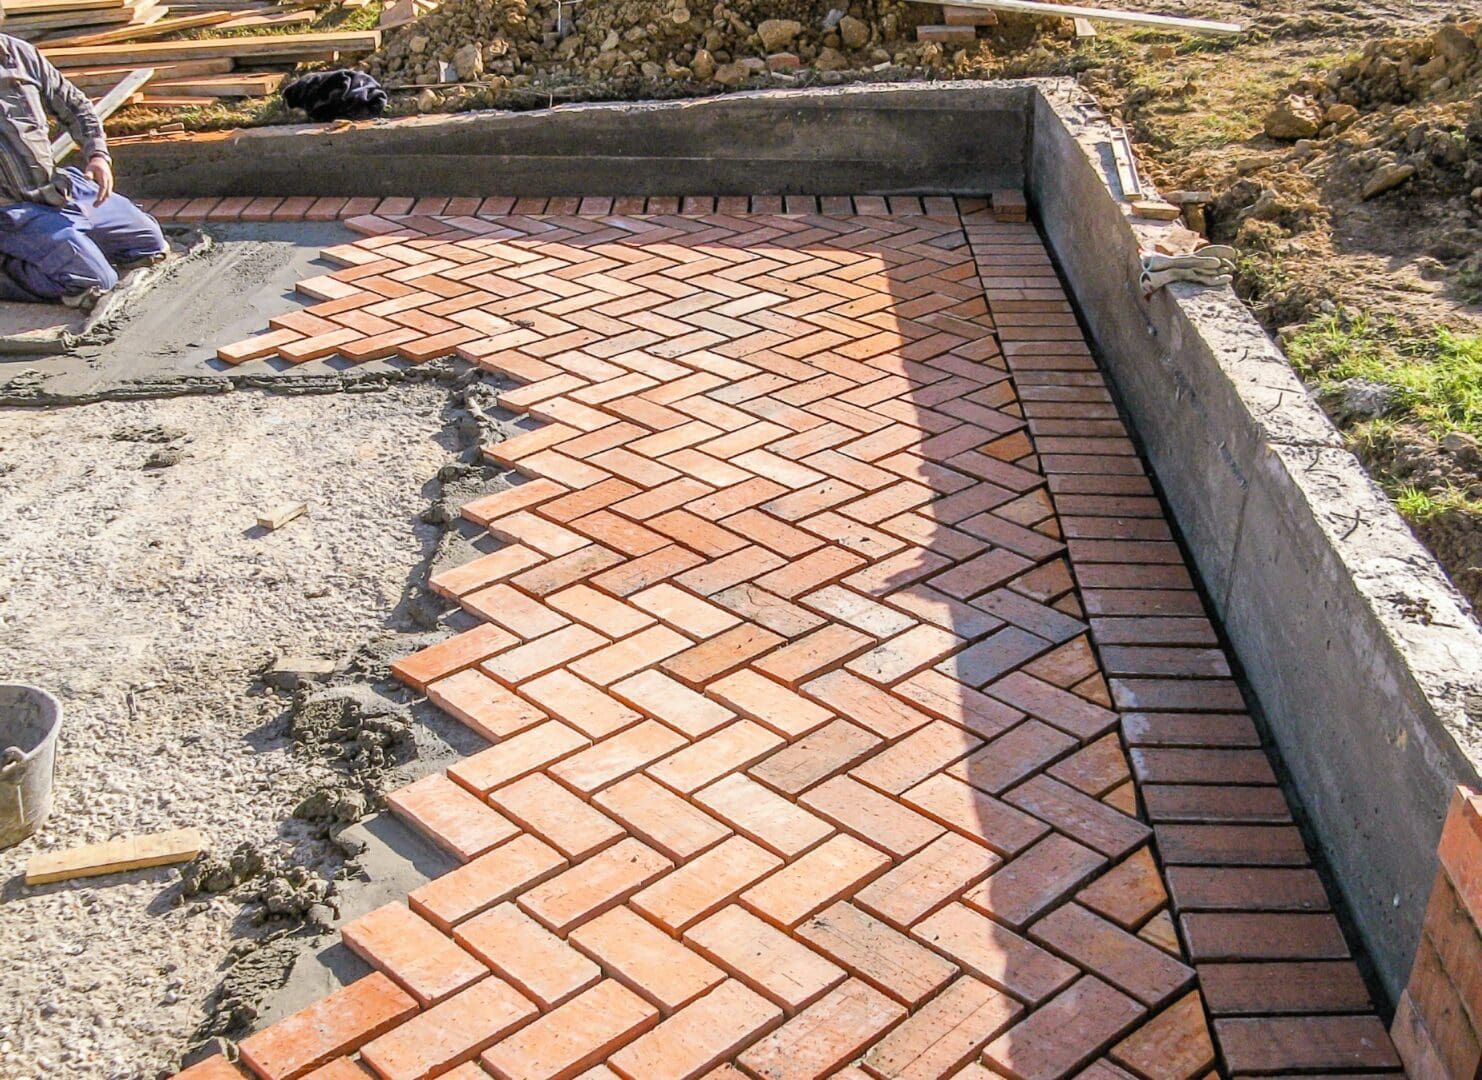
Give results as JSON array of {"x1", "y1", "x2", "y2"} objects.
[{"x1": 114, "y1": 83, "x2": 1033, "y2": 199}]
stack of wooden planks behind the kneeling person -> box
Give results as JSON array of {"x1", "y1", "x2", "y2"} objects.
[{"x1": 0, "y1": 0, "x2": 381, "y2": 108}]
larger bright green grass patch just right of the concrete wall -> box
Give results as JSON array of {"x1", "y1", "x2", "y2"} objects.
[{"x1": 1286, "y1": 314, "x2": 1482, "y2": 437}]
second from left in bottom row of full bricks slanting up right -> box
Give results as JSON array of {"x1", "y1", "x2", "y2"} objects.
[{"x1": 360, "y1": 979, "x2": 539, "y2": 1080}]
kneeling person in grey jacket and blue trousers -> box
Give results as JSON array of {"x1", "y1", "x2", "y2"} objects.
[{"x1": 0, "y1": 34, "x2": 169, "y2": 308}]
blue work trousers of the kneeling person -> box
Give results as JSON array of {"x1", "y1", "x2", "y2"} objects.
[{"x1": 0, "y1": 167, "x2": 166, "y2": 302}]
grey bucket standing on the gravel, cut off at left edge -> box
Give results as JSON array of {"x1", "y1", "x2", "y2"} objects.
[{"x1": 0, "y1": 683, "x2": 62, "y2": 847}]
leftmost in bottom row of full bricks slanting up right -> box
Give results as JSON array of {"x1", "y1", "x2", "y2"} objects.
[{"x1": 237, "y1": 972, "x2": 416, "y2": 1080}]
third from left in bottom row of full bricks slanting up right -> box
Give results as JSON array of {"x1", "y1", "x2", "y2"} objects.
[{"x1": 480, "y1": 979, "x2": 658, "y2": 1080}]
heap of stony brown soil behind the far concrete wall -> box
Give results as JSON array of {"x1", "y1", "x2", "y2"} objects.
[{"x1": 365, "y1": 0, "x2": 1070, "y2": 95}]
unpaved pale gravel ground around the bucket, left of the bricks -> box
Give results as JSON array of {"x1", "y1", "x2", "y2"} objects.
[{"x1": 0, "y1": 384, "x2": 456, "y2": 1080}]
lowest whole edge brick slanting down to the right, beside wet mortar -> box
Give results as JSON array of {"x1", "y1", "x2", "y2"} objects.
[{"x1": 339, "y1": 904, "x2": 489, "y2": 1007}]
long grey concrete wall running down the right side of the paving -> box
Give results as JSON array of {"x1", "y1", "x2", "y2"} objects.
[{"x1": 1029, "y1": 84, "x2": 1482, "y2": 999}]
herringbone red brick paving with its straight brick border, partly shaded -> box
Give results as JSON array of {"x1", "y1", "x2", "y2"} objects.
[{"x1": 179, "y1": 197, "x2": 1399, "y2": 1080}]
